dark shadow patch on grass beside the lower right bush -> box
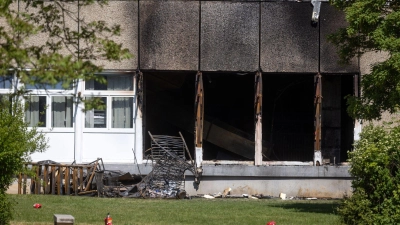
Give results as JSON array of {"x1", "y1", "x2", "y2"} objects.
[{"x1": 271, "y1": 202, "x2": 340, "y2": 214}]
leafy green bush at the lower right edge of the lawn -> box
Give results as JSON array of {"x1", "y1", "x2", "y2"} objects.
[{"x1": 338, "y1": 126, "x2": 400, "y2": 224}]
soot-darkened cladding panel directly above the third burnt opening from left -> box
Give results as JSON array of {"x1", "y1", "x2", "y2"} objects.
[{"x1": 260, "y1": 2, "x2": 319, "y2": 73}]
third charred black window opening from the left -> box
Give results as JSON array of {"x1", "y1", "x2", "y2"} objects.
[{"x1": 263, "y1": 74, "x2": 314, "y2": 161}]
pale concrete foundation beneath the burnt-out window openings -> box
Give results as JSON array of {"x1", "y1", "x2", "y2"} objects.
[{"x1": 105, "y1": 163, "x2": 352, "y2": 198}]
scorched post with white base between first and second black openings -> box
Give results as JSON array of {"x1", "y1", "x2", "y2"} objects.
[{"x1": 194, "y1": 72, "x2": 204, "y2": 167}]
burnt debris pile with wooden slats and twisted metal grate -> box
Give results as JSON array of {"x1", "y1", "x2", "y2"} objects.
[{"x1": 18, "y1": 132, "x2": 198, "y2": 198}]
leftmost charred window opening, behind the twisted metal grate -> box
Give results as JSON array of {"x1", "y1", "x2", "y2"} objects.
[{"x1": 143, "y1": 72, "x2": 196, "y2": 160}]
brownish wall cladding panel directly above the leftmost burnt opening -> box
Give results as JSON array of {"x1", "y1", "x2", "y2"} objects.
[{"x1": 139, "y1": 0, "x2": 200, "y2": 70}]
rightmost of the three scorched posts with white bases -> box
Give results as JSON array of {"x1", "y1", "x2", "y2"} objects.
[{"x1": 314, "y1": 73, "x2": 322, "y2": 166}]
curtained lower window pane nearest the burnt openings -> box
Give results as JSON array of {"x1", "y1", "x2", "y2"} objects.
[{"x1": 112, "y1": 97, "x2": 133, "y2": 128}]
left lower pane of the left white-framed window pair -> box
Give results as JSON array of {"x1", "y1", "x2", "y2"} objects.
[{"x1": 25, "y1": 96, "x2": 47, "y2": 127}]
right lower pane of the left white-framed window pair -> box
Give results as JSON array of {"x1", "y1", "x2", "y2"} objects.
[{"x1": 51, "y1": 96, "x2": 73, "y2": 127}]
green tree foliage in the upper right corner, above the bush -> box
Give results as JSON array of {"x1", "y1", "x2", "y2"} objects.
[{"x1": 330, "y1": 0, "x2": 400, "y2": 120}]
